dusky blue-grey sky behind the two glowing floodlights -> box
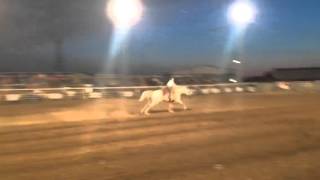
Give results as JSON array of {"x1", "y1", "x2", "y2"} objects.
[{"x1": 0, "y1": 0, "x2": 320, "y2": 74}]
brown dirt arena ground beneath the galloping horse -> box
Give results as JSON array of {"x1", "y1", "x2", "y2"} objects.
[{"x1": 0, "y1": 94, "x2": 320, "y2": 180}]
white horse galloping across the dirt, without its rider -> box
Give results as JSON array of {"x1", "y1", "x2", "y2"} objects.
[{"x1": 139, "y1": 86, "x2": 192, "y2": 115}]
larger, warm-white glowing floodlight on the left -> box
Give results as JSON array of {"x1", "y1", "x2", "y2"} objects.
[{"x1": 106, "y1": 0, "x2": 143, "y2": 29}]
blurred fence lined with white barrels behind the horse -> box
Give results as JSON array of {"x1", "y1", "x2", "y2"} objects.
[{"x1": 0, "y1": 81, "x2": 320, "y2": 103}]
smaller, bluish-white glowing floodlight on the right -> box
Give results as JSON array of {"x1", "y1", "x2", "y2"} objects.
[{"x1": 228, "y1": 0, "x2": 257, "y2": 26}]
